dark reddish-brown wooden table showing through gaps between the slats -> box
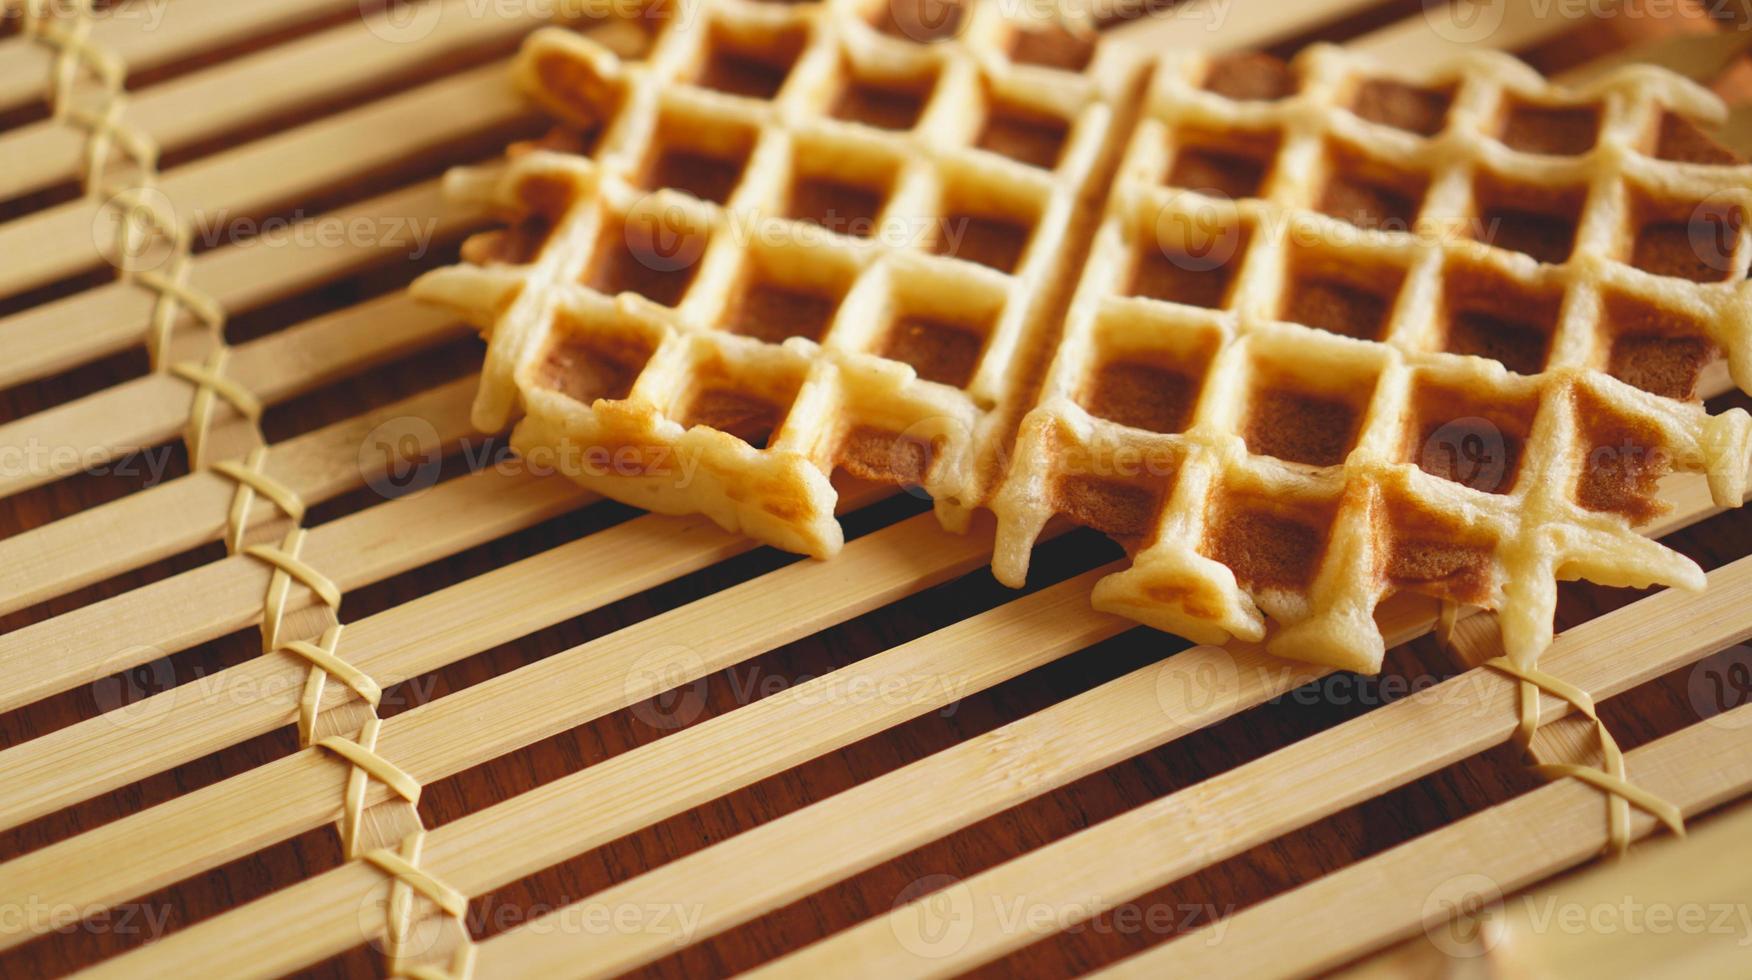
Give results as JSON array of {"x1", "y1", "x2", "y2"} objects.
[{"x1": 0, "y1": 5, "x2": 1752, "y2": 978}]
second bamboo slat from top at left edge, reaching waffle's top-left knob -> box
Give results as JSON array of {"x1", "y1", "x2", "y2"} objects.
[{"x1": 0, "y1": 0, "x2": 543, "y2": 196}]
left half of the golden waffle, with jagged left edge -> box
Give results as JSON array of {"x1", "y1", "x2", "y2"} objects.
[{"x1": 415, "y1": 0, "x2": 1142, "y2": 557}]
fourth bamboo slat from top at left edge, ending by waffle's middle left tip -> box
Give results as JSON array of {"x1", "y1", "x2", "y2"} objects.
[{"x1": 0, "y1": 181, "x2": 482, "y2": 387}]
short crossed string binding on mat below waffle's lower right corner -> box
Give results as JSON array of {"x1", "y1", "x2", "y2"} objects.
[{"x1": 1484, "y1": 657, "x2": 1685, "y2": 856}]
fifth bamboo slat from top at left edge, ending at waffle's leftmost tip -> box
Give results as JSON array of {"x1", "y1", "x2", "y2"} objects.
[{"x1": 0, "y1": 291, "x2": 468, "y2": 498}]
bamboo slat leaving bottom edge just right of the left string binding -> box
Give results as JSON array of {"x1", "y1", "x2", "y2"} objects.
[{"x1": 462, "y1": 459, "x2": 1752, "y2": 976}]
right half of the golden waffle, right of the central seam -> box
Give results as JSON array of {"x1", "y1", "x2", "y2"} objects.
[{"x1": 992, "y1": 47, "x2": 1752, "y2": 671}]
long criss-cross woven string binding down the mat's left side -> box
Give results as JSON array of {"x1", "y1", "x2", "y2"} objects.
[{"x1": 20, "y1": 0, "x2": 475, "y2": 980}]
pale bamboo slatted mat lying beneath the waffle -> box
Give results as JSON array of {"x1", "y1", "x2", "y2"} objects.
[{"x1": 0, "y1": 0, "x2": 1752, "y2": 976}]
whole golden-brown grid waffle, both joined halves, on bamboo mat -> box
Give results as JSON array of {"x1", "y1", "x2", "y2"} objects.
[{"x1": 415, "y1": 7, "x2": 1752, "y2": 671}]
